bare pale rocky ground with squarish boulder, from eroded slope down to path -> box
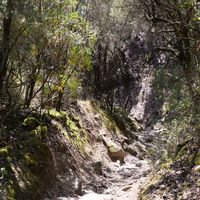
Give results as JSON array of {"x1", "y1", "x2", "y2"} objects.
[{"x1": 41, "y1": 102, "x2": 151, "y2": 200}]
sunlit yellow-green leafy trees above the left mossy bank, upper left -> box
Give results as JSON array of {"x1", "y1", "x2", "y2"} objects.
[{"x1": 0, "y1": 0, "x2": 97, "y2": 106}]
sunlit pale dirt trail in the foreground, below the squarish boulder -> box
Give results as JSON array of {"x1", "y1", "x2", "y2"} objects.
[{"x1": 57, "y1": 155, "x2": 150, "y2": 200}]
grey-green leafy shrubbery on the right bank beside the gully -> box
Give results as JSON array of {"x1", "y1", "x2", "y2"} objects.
[{"x1": 153, "y1": 61, "x2": 198, "y2": 160}]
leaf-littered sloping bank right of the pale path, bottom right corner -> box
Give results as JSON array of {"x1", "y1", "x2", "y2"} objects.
[{"x1": 140, "y1": 137, "x2": 200, "y2": 200}]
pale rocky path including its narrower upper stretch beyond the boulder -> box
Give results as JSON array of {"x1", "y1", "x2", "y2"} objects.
[{"x1": 52, "y1": 119, "x2": 167, "y2": 200}]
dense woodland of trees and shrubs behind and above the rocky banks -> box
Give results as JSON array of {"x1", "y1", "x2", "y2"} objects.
[{"x1": 0, "y1": 0, "x2": 200, "y2": 200}]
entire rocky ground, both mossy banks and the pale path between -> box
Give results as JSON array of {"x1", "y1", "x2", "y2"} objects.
[{"x1": 3, "y1": 101, "x2": 200, "y2": 200}]
